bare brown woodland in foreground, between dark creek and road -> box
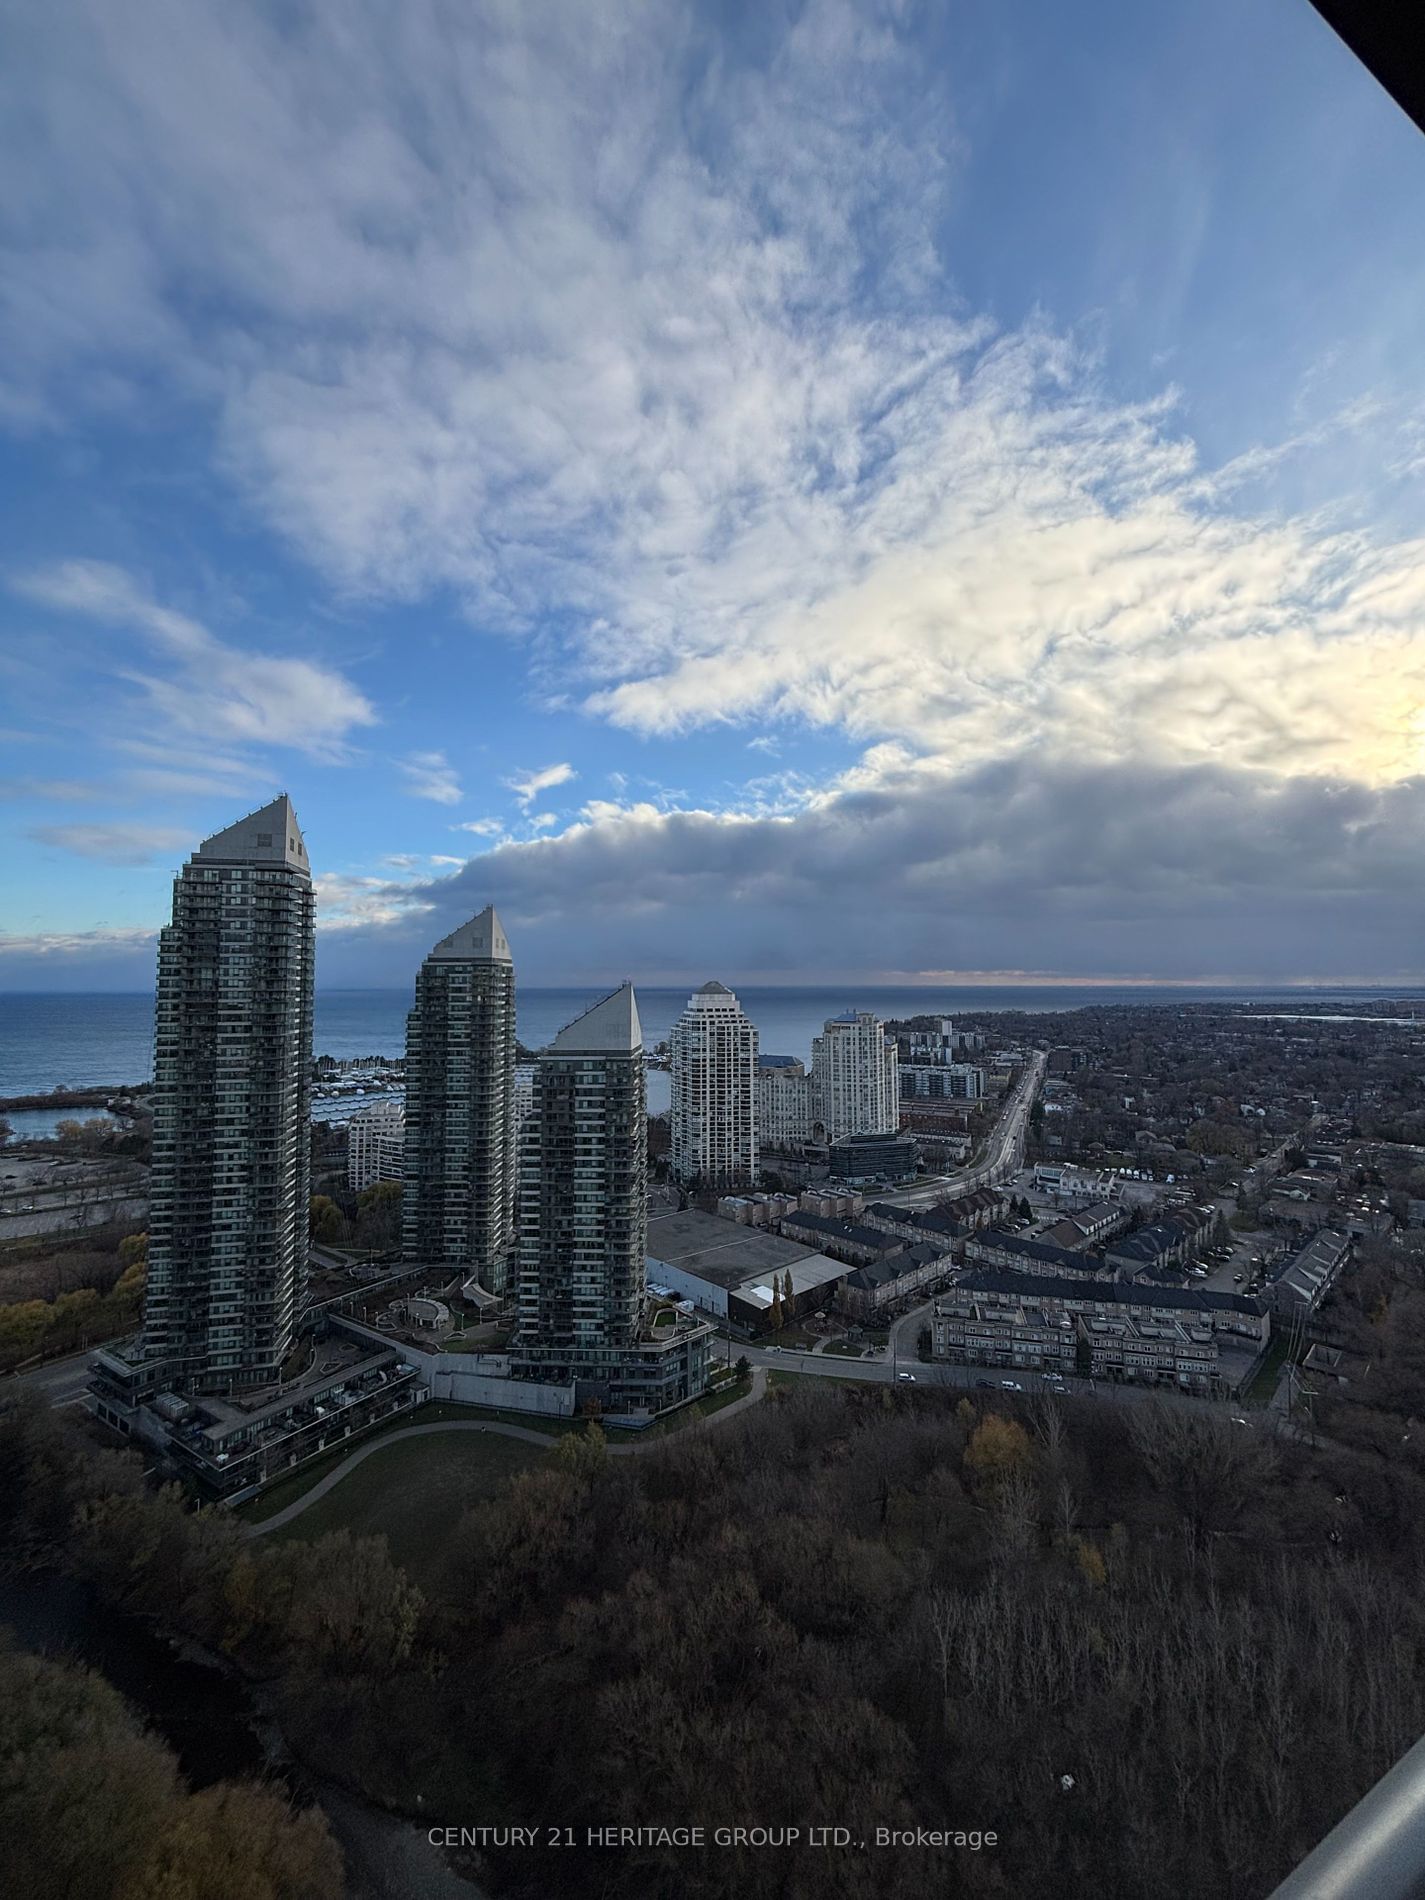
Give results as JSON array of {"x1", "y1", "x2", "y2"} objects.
[{"x1": 0, "y1": 1385, "x2": 1425, "y2": 1900}]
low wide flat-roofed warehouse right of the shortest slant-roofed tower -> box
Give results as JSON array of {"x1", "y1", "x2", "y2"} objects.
[{"x1": 648, "y1": 1208, "x2": 851, "y2": 1332}]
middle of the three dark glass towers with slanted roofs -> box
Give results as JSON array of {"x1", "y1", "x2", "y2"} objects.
[{"x1": 401, "y1": 908, "x2": 517, "y2": 1294}]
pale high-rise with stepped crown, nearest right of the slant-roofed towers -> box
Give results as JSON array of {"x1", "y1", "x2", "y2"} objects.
[{"x1": 669, "y1": 982, "x2": 758, "y2": 1191}]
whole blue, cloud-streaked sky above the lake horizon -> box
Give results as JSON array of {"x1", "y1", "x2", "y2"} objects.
[{"x1": 0, "y1": 0, "x2": 1425, "y2": 990}]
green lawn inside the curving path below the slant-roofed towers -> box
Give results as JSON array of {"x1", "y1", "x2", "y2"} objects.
[{"x1": 272, "y1": 1431, "x2": 549, "y2": 1590}]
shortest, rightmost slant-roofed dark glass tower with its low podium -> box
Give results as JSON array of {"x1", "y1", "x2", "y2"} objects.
[{"x1": 509, "y1": 982, "x2": 710, "y2": 1414}]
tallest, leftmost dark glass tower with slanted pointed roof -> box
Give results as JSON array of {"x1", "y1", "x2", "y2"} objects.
[{"x1": 95, "y1": 796, "x2": 315, "y2": 1410}]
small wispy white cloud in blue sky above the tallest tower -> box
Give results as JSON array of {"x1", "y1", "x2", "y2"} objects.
[{"x1": 11, "y1": 561, "x2": 376, "y2": 760}]
